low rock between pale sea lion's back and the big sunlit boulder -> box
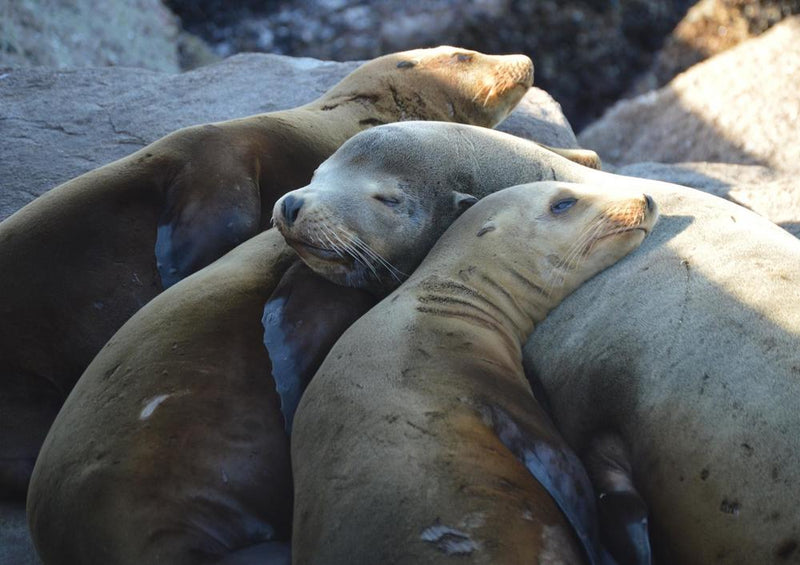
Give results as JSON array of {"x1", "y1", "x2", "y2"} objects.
[{"x1": 615, "y1": 163, "x2": 800, "y2": 237}]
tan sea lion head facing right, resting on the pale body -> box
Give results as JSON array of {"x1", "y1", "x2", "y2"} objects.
[{"x1": 428, "y1": 181, "x2": 658, "y2": 306}]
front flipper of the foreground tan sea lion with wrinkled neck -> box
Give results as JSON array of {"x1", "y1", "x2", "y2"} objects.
[{"x1": 483, "y1": 405, "x2": 613, "y2": 565}]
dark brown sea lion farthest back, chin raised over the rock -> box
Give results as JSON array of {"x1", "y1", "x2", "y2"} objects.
[{"x1": 0, "y1": 47, "x2": 532, "y2": 496}]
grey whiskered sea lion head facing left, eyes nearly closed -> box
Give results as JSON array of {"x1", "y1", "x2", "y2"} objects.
[{"x1": 273, "y1": 122, "x2": 494, "y2": 294}]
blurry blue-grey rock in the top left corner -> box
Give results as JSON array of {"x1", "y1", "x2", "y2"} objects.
[{"x1": 0, "y1": 0, "x2": 179, "y2": 72}]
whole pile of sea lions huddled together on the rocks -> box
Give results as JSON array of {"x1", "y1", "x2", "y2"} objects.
[{"x1": 0, "y1": 47, "x2": 800, "y2": 565}]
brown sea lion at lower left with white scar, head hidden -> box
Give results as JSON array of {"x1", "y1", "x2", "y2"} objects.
[{"x1": 28, "y1": 230, "x2": 374, "y2": 565}]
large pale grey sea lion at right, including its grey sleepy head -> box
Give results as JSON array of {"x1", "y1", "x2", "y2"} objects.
[{"x1": 275, "y1": 123, "x2": 800, "y2": 565}]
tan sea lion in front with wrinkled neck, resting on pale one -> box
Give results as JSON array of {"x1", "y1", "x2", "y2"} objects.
[{"x1": 292, "y1": 183, "x2": 657, "y2": 565}]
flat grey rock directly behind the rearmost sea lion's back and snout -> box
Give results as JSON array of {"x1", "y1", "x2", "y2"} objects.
[{"x1": 0, "y1": 54, "x2": 576, "y2": 219}]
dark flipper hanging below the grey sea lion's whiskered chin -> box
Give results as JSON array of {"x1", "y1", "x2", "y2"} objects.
[{"x1": 261, "y1": 261, "x2": 377, "y2": 433}]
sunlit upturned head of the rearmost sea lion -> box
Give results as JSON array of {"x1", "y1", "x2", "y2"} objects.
[{"x1": 323, "y1": 45, "x2": 533, "y2": 127}]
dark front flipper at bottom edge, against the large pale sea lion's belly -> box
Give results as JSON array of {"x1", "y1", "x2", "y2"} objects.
[{"x1": 583, "y1": 434, "x2": 652, "y2": 565}]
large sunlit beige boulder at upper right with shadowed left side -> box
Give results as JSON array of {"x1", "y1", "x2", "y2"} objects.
[{"x1": 579, "y1": 16, "x2": 800, "y2": 171}]
